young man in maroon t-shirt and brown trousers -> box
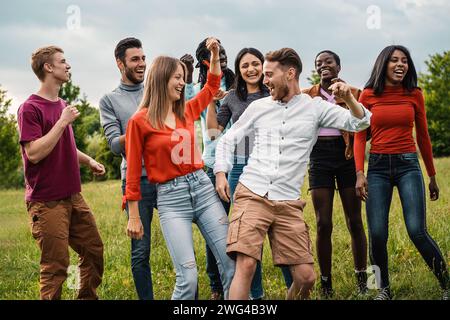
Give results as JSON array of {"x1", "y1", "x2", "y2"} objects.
[{"x1": 17, "y1": 46, "x2": 105, "y2": 300}]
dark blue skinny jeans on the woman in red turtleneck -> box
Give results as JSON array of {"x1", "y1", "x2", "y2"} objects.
[{"x1": 366, "y1": 153, "x2": 448, "y2": 288}]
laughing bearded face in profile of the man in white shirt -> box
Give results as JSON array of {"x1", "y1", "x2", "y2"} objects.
[{"x1": 263, "y1": 60, "x2": 289, "y2": 101}]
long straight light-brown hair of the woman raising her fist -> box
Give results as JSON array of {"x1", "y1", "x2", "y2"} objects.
[{"x1": 139, "y1": 56, "x2": 187, "y2": 129}]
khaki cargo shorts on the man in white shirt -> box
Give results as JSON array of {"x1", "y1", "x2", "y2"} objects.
[{"x1": 227, "y1": 183, "x2": 314, "y2": 266}]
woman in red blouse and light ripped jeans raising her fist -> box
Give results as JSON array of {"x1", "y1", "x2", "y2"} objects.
[{"x1": 124, "y1": 38, "x2": 234, "y2": 300}]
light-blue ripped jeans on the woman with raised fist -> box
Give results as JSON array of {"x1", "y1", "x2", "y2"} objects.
[{"x1": 157, "y1": 170, "x2": 235, "y2": 300}]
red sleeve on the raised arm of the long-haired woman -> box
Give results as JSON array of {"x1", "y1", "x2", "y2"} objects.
[{"x1": 186, "y1": 72, "x2": 221, "y2": 120}]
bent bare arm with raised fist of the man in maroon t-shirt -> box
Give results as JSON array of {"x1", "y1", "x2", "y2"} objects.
[{"x1": 24, "y1": 106, "x2": 80, "y2": 164}]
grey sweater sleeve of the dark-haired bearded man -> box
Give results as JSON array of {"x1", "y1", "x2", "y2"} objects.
[{"x1": 99, "y1": 96, "x2": 125, "y2": 155}]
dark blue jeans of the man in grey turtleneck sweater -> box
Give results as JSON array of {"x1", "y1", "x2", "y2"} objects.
[{"x1": 122, "y1": 177, "x2": 156, "y2": 300}]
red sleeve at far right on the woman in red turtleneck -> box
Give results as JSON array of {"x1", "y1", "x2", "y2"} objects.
[{"x1": 415, "y1": 90, "x2": 436, "y2": 177}]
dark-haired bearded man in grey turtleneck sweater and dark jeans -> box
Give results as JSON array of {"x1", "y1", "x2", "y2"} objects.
[{"x1": 100, "y1": 38, "x2": 156, "y2": 300}]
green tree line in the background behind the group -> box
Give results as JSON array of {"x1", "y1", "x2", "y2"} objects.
[{"x1": 0, "y1": 51, "x2": 450, "y2": 189}]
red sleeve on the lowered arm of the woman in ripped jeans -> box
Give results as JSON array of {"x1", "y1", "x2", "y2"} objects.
[{"x1": 122, "y1": 117, "x2": 144, "y2": 210}]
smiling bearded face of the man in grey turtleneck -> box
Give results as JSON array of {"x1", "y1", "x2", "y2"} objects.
[{"x1": 118, "y1": 48, "x2": 147, "y2": 84}]
